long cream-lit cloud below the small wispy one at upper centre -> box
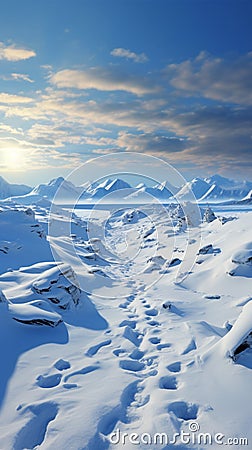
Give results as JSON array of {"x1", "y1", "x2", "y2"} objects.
[{"x1": 50, "y1": 67, "x2": 157, "y2": 95}]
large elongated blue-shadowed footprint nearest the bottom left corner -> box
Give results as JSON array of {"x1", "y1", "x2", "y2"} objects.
[{"x1": 13, "y1": 402, "x2": 58, "y2": 450}]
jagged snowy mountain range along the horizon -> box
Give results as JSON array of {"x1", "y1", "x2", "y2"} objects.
[{"x1": 0, "y1": 175, "x2": 252, "y2": 204}]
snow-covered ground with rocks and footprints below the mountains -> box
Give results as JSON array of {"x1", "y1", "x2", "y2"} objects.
[{"x1": 0, "y1": 197, "x2": 252, "y2": 450}]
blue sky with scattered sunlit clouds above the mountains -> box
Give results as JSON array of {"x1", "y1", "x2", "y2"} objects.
[{"x1": 0, "y1": 0, "x2": 252, "y2": 185}]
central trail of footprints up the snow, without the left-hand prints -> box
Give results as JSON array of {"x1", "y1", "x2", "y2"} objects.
[{"x1": 98, "y1": 292, "x2": 201, "y2": 442}]
